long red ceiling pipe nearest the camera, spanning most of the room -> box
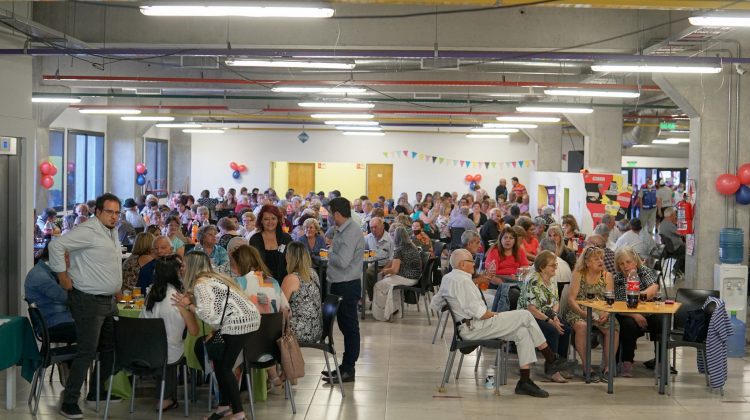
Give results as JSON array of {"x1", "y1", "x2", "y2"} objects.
[{"x1": 43, "y1": 75, "x2": 661, "y2": 91}]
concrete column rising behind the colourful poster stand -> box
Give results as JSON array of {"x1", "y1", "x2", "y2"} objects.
[{"x1": 565, "y1": 107, "x2": 622, "y2": 174}]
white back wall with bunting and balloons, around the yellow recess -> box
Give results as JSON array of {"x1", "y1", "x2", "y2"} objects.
[{"x1": 191, "y1": 130, "x2": 536, "y2": 197}]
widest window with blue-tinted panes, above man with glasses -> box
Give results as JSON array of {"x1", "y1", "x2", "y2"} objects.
[{"x1": 65, "y1": 130, "x2": 104, "y2": 209}]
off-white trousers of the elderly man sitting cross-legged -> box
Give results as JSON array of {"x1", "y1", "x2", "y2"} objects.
[{"x1": 460, "y1": 310, "x2": 547, "y2": 366}]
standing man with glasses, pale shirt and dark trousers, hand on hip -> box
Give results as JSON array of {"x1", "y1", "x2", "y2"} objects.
[{"x1": 49, "y1": 193, "x2": 122, "y2": 419}]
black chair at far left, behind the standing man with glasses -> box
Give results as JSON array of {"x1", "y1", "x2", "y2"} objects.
[{"x1": 28, "y1": 303, "x2": 78, "y2": 416}]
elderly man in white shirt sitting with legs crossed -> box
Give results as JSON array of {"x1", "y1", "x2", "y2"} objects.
[{"x1": 430, "y1": 249, "x2": 567, "y2": 398}]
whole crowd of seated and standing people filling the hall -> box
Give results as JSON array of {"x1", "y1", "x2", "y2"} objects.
[{"x1": 26, "y1": 174, "x2": 684, "y2": 418}]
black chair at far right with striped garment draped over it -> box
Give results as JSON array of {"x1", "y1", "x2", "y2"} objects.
[{"x1": 664, "y1": 288, "x2": 720, "y2": 386}]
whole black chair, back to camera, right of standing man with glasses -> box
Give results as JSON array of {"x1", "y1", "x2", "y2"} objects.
[{"x1": 104, "y1": 317, "x2": 181, "y2": 420}]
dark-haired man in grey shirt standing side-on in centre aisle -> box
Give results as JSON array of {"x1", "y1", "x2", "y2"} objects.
[{"x1": 321, "y1": 197, "x2": 365, "y2": 385}]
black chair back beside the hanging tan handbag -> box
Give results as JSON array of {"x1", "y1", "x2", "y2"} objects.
[{"x1": 243, "y1": 312, "x2": 284, "y2": 367}]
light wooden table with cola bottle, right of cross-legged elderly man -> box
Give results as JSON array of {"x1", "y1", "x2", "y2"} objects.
[{"x1": 576, "y1": 300, "x2": 681, "y2": 394}]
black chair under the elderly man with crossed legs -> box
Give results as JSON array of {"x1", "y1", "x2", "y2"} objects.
[{"x1": 438, "y1": 302, "x2": 508, "y2": 395}]
